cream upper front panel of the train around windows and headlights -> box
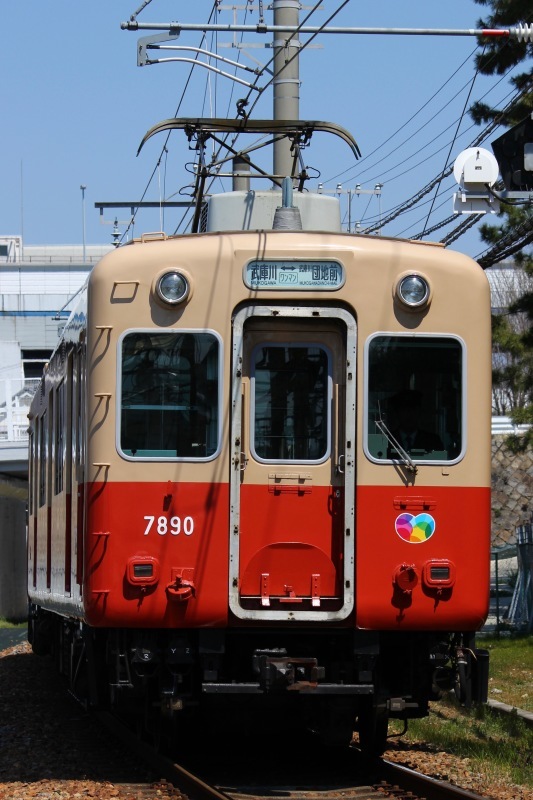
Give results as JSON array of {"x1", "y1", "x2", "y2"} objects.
[{"x1": 87, "y1": 231, "x2": 491, "y2": 486}]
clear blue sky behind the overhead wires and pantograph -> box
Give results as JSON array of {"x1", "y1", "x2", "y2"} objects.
[{"x1": 0, "y1": 0, "x2": 519, "y2": 256}]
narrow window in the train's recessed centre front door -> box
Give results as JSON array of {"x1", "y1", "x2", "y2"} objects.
[{"x1": 251, "y1": 344, "x2": 330, "y2": 462}]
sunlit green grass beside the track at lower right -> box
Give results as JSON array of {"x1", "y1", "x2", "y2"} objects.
[{"x1": 391, "y1": 637, "x2": 533, "y2": 787}]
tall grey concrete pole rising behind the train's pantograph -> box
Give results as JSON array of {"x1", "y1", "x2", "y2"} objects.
[{"x1": 272, "y1": 0, "x2": 300, "y2": 176}]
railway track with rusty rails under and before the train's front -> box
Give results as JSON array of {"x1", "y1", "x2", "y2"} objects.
[{"x1": 99, "y1": 714, "x2": 486, "y2": 800}]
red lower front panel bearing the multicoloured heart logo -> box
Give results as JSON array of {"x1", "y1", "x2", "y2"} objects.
[{"x1": 355, "y1": 486, "x2": 490, "y2": 631}]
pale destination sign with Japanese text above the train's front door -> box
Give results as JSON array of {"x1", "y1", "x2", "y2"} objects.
[{"x1": 244, "y1": 259, "x2": 344, "y2": 292}]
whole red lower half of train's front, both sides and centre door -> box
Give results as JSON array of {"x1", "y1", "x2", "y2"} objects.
[{"x1": 83, "y1": 482, "x2": 490, "y2": 631}]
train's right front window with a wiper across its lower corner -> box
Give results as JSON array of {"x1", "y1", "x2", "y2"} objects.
[{"x1": 366, "y1": 335, "x2": 464, "y2": 462}]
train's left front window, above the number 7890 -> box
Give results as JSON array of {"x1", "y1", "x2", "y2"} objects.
[{"x1": 118, "y1": 331, "x2": 220, "y2": 460}]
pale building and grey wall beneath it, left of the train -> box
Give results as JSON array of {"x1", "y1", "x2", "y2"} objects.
[{"x1": 0, "y1": 236, "x2": 112, "y2": 619}]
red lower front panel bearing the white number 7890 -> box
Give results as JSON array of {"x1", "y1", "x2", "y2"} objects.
[{"x1": 83, "y1": 481, "x2": 228, "y2": 628}]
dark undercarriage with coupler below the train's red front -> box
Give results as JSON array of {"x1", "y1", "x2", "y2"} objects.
[{"x1": 29, "y1": 606, "x2": 488, "y2": 755}]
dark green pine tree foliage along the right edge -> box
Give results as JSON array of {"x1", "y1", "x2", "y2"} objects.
[{"x1": 470, "y1": 0, "x2": 533, "y2": 447}]
